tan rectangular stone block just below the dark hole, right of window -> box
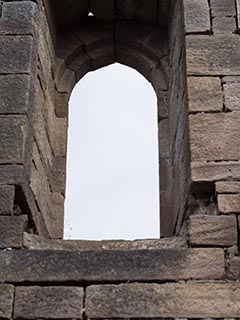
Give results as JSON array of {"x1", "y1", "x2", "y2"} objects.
[{"x1": 188, "y1": 215, "x2": 238, "y2": 247}]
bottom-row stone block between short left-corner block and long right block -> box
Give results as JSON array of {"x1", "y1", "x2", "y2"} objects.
[{"x1": 14, "y1": 286, "x2": 83, "y2": 319}]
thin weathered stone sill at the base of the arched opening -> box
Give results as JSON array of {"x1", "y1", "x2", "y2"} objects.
[{"x1": 23, "y1": 233, "x2": 187, "y2": 250}]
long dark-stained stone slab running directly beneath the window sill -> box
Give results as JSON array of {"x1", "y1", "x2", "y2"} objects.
[{"x1": 0, "y1": 248, "x2": 225, "y2": 283}]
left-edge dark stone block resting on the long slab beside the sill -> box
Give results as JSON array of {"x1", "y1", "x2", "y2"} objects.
[{"x1": 0, "y1": 216, "x2": 28, "y2": 249}]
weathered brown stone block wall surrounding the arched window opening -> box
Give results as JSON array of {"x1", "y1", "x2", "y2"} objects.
[{"x1": 0, "y1": 0, "x2": 240, "y2": 320}]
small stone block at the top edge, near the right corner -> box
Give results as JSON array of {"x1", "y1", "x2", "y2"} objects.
[{"x1": 210, "y1": 0, "x2": 236, "y2": 17}]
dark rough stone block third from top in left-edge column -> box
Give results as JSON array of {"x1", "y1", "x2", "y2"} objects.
[{"x1": 0, "y1": 75, "x2": 31, "y2": 114}]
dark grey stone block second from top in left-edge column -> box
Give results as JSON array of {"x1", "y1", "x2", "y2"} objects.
[{"x1": 0, "y1": 36, "x2": 33, "y2": 74}]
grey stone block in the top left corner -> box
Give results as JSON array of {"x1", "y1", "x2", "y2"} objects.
[{"x1": 0, "y1": 1, "x2": 38, "y2": 36}]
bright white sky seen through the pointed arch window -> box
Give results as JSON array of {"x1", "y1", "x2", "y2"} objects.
[{"x1": 64, "y1": 64, "x2": 159, "y2": 240}]
